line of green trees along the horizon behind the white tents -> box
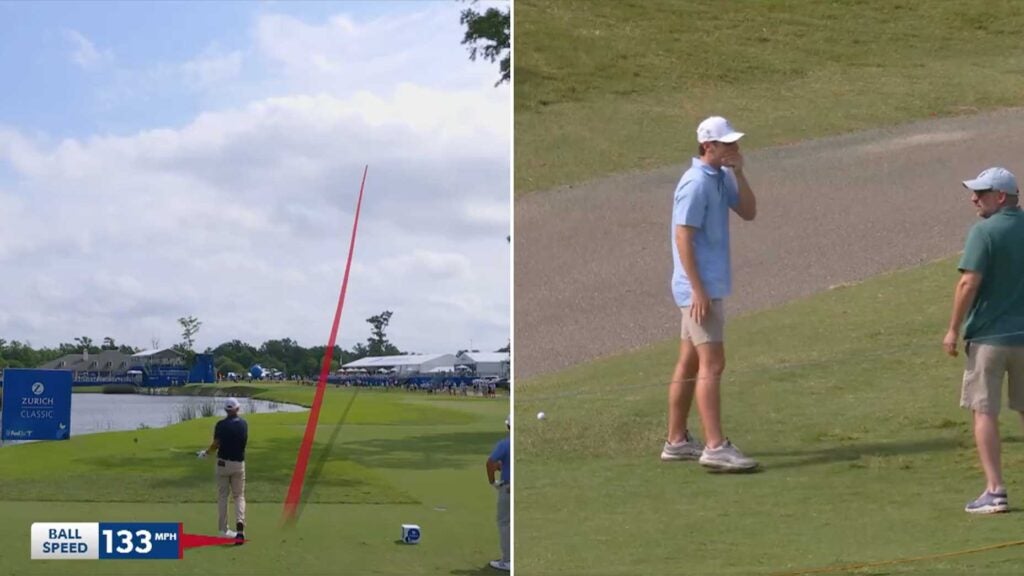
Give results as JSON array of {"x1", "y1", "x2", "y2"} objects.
[{"x1": 0, "y1": 311, "x2": 510, "y2": 376}]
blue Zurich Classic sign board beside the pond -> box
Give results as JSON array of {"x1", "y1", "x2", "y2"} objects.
[{"x1": 0, "y1": 368, "x2": 72, "y2": 441}]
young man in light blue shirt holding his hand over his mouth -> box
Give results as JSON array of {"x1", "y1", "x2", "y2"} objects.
[{"x1": 662, "y1": 116, "x2": 758, "y2": 471}]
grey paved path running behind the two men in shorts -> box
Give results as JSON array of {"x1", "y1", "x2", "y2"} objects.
[{"x1": 514, "y1": 110, "x2": 1024, "y2": 378}]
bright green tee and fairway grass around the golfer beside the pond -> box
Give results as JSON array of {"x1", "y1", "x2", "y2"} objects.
[{"x1": 0, "y1": 383, "x2": 509, "y2": 576}]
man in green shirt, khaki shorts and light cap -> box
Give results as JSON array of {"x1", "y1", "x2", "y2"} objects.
[{"x1": 942, "y1": 167, "x2": 1024, "y2": 513}]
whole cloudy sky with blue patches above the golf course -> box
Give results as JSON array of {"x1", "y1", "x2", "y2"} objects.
[{"x1": 0, "y1": 1, "x2": 511, "y2": 353}]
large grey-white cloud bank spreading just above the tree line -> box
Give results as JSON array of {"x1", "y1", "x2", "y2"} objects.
[{"x1": 0, "y1": 79, "x2": 511, "y2": 352}]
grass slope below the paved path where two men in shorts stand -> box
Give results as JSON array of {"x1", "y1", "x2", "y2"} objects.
[{"x1": 514, "y1": 259, "x2": 1024, "y2": 576}]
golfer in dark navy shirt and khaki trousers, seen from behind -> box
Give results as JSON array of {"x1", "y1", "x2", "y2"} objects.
[{"x1": 199, "y1": 398, "x2": 249, "y2": 545}]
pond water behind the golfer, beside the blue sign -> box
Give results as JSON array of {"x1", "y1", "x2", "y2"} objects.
[{"x1": 1, "y1": 393, "x2": 308, "y2": 438}]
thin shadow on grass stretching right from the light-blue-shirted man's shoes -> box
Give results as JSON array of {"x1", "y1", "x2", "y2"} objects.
[{"x1": 756, "y1": 438, "x2": 963, "y2": 470}]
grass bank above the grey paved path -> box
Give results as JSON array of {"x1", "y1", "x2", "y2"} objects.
[{"x1": 514, "y1": 0, "x2": 1024, "y2": 196}]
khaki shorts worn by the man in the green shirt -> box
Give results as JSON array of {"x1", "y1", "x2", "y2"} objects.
[{"x1": 961, "y1": 343, "x2": 1024, "y2": 414}]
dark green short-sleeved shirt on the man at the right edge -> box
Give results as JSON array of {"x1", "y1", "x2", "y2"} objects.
[{"x1": 958, "y1": 207, "x2": 1024, "y2": 345}]
